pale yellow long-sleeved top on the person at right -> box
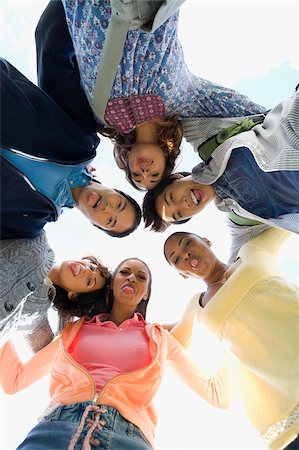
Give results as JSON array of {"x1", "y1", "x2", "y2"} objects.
[{"x1": 172, "y1": 228, "x2": 299, "y2": 450}]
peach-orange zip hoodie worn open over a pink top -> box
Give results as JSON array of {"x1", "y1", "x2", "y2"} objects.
[{"x1": 0, "y1": 318, "x2": 230, "y2": 447}]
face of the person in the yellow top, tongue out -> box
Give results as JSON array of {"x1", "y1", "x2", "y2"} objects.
[{"x1": 164, "y1": 233, "x2": 217, "y2": 279}]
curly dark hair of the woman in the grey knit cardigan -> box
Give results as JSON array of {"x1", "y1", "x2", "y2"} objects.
[{"x1": 53, "y1": 255, "x2": 111, "y2": 322}]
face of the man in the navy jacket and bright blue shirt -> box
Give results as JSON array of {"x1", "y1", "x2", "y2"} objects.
[{"x1": 76, "y1": 182, "x2": 136, "y2": 233}]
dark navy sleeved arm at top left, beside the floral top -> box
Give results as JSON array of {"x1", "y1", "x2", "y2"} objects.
[{"x1": 35, "y1": 0, "x2": 97, "y2": 132}]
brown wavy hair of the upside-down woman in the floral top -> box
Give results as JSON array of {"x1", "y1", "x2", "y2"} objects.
[{"x1": 98, "y1": 115, "x2": 183, "y2": 191}]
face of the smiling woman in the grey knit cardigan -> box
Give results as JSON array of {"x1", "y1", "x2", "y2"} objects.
[{"x1": 59, "y1": 259, "x2": 106, "y2": 296}]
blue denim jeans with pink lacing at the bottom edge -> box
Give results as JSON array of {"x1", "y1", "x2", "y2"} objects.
[{"x1": 17, "y1": 402, "x2": 152, "y2": 450}]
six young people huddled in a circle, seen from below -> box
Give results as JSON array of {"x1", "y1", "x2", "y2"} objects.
[{"x1": 0, "y1": 0, "x2": 299, "y2": 450}]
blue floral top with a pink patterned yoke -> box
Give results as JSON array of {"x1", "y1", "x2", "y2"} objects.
[{"x1": 62, "y1": 0, "x2": 264, "y2": 132}]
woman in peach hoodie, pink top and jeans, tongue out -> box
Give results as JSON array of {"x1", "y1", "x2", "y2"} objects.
[{"x1": 0, "y1": 258, "x2": 229, "y2": 450}]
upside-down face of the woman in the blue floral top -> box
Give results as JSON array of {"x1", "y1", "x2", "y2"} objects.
[{"x1": 128, "y1": 143, "x2": 166, "y2": 190}]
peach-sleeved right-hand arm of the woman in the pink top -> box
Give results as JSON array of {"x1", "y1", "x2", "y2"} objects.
[{"x1": 168, "y1": 335, "x2": 232, "y2": 408}]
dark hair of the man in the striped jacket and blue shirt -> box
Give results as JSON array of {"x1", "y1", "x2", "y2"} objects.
[{"x1": 142, "y1": 172, "x2": 190, "y2": 233}]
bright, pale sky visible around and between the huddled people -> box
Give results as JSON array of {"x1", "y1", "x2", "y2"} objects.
[{"x1": 0, "y1": 0, "x2": 299, "y2": 450}]
